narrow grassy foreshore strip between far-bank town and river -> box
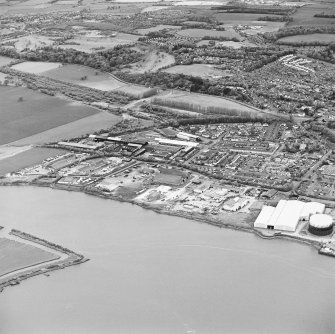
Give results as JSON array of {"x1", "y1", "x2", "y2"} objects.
[{"x1": 3, "y1": 183, "x2": 335, "y2": 257}]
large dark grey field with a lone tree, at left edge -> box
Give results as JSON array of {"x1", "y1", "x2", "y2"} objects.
[{"x1": 0, "y1": 86, "x2": 97, "y2": 144}]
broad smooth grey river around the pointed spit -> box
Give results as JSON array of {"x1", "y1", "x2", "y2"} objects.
[{"x1": 0, "y1": 187, "x2": 335, "y2": 334}]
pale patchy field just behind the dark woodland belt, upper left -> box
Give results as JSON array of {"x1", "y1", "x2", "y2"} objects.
[{"x1": 59, "y1": 32, "x2": 140, "y2": 53}]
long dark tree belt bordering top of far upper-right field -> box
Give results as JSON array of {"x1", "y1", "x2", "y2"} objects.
[{"x1": 264, "y1": 25, "x2": 335, "y2": 42}]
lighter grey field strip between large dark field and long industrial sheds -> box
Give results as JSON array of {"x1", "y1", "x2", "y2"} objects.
[{"x1": 6, "y1": 111, "x2": 122, "y2": 145}]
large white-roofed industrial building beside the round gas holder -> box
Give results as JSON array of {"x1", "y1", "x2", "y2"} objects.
[{"x1": 254, "y1": 200, "x2": 325, "y2": 232}]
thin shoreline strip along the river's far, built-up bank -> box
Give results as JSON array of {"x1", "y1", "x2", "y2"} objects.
[{"x1": 1, "y1": 182, "x2": 335, "y2": 257}]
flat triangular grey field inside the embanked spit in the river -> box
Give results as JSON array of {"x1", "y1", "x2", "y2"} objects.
[{"x1": 0, "y1": 238, "x2": 59, "y2": 277}]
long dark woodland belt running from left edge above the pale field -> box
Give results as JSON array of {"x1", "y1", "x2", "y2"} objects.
[{"x1": 0, "y1": 45, "x2": 142, "y2": 72}]
